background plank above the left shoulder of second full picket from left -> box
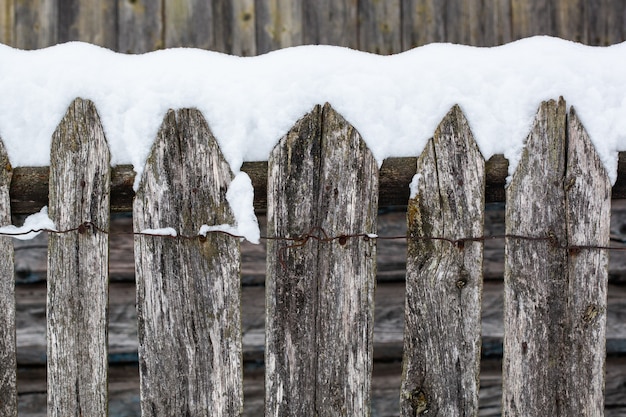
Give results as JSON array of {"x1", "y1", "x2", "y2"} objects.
[{"x1": 116, "y1": 0, "x2": 164, "y2": 54}]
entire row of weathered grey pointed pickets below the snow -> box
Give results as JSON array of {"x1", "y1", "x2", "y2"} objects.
[{"x1": 0, "y1": 99, "x2": 611, "y2": 416}]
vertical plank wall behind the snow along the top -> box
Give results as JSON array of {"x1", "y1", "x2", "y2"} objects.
[{"x1": 0, "y1": 0, "x2": 626, "y2": 52}]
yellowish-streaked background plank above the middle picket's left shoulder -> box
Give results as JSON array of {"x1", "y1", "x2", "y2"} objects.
[{"x1": 254, "y1": 0, "x2": 304, "y2": 54}]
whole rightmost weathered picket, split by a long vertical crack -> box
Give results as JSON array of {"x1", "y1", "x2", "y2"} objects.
[{"x1": 503, "y1": 99, "x2": 610, "y2": 417}]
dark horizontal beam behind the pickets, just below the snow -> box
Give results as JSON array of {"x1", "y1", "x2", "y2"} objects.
[{"x1": 11, "y1": 152, "x2": 626, "y2": 214}]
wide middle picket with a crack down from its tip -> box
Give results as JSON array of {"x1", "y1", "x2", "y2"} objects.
[{"x1": 265, "y1": 105, "x2": 378, "y2": 416}]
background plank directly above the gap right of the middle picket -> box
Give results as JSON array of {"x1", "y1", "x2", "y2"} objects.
[{"x1": 358, "y1": 0, "x2": 402, "y2": 55}]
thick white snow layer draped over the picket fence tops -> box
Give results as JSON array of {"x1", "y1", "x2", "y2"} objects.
[{"x1": 0, "y1": 37, "x2": 626, "y2": 240}]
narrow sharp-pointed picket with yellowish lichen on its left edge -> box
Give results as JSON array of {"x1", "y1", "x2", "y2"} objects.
[{"x1": 400, "y1": 106, "x2": 485, "y2": 417}]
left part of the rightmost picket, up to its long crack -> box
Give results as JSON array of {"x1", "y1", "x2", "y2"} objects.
[{"x1": 503, "y1": 96, "x2": 567, "y2": 416}]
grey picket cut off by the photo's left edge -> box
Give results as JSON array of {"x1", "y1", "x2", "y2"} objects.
[{"x1": 0, "y1": 136, "x2": 17, "y2": 417}]
